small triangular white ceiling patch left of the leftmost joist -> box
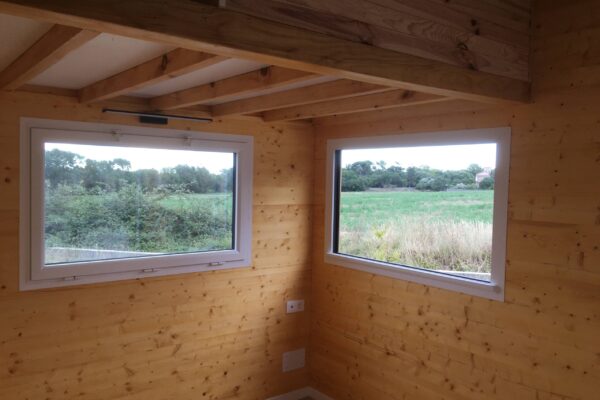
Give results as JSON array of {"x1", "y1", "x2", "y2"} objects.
[{"x1": 0, "y1": 14, "x2": 52, "y2": 71}]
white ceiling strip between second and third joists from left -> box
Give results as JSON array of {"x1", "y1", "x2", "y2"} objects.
[{"x1": 129, "y1": 58, "x2": 266, "y2": 97}]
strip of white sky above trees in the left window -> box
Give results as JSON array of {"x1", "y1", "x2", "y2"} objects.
[{"x1": 45, "y1": 143, "x2": 233, "y2": 174}]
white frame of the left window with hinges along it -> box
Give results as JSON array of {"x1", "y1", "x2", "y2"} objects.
[{"x1": 20, "y1": 118, "x2": 253, "y2": 290}]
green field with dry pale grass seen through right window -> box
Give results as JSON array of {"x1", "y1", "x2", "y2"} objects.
[{"x1": 340, "y1": 190, "x2": 493, "y2": 273}]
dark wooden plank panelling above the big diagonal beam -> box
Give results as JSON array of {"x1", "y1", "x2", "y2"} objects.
[{"x1": 221, "y1": 0, "x2": 531, "y2": 81}]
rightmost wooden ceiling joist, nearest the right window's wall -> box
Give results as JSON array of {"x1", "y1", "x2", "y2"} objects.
[{"x1": 263, "y1": 90, "x2": 450, "y2": 122}]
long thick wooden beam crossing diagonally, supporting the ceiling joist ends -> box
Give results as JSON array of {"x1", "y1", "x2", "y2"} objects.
[{"x1": 0, "y1": 0, "x2": 530, "y2": 103}]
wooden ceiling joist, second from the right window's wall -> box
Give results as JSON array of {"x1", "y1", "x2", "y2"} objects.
[{"x1": 212, "y1": 79, "x2": 391, "y2": 117}]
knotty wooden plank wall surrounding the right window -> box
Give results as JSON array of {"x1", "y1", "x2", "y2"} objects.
[{"x1": 311, "y1": 0, "x2": 600, "y2": 400}]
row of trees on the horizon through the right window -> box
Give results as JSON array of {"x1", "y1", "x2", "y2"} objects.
[{"x1": 342, "y1": 161, "x2": 494, "y2": 192}]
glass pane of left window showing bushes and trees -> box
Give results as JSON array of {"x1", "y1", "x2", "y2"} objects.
[{"x1": 44, "y1": 143, "x2": 235, "y2": 265}]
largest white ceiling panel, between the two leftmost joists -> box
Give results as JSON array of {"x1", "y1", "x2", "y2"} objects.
[{"x1": 29, "y1": 33, "x2": 173, "y2": 89}]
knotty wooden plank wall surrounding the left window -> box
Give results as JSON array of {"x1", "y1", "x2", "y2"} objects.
[{"x1": 0, "y1": 92, "x2": 313, "y2": 400}]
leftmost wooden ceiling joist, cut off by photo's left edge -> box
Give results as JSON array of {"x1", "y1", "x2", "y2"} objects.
[{"x1": 0, "y1": 25, "x2": 98, "y2": 90}]
